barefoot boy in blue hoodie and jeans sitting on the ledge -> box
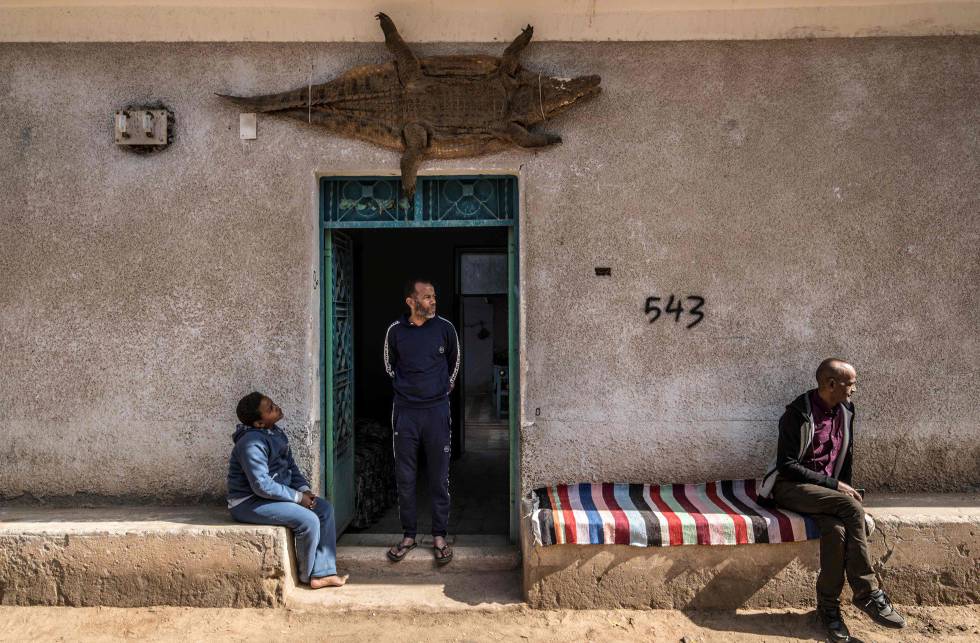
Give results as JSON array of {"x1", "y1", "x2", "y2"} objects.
[{"x1": 228, "y1": 393, "x2": 347, "y2": 589}]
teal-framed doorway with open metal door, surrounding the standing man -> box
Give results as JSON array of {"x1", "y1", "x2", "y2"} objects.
[{"x1": 321, "y1": 176, "x2": 517, "y2": 541}]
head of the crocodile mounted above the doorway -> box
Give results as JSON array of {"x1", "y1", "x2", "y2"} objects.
[{"x1": 511, "y1": 69, "x2": 602, "y2": 125}]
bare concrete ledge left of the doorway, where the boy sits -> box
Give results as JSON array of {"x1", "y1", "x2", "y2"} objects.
[{"x1": 0, "y1": 507, "x2": 294, "y2": 607}]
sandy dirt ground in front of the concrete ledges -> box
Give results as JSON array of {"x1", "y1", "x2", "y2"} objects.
[{"x1": 0, "y1": 605, "x2": 980, "y2": 643}]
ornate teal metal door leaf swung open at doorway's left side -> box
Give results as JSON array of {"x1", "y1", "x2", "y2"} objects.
[{"x1": 323, "y1": 230, "x2": 354, "y2": 535}]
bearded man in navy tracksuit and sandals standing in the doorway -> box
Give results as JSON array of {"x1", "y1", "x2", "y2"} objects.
[{"x1": 384, "y1": 279, "x2": 461, "y2": 564}]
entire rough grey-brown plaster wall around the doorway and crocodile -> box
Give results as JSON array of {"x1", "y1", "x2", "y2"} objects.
[{"x1": 0, "y1": 38, "x2": 980, "y2": 499}]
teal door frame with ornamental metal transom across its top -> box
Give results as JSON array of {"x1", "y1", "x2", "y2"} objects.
[{"x1": 318, "y1": 174, "x2": 521, "y2": 542}]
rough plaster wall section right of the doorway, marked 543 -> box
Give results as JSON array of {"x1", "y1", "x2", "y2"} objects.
[{"x1": 522, "y1": 39, "x2": 980, "y2": 490}]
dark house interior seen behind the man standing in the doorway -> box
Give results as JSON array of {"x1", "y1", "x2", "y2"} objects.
[{"x1": 350, "y1": 228, "x2": 509, "y2": 535}]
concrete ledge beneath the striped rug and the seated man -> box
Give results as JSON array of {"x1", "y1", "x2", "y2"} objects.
[{"x1": 522, "y1": 495, "x2": 980, "y2": 609}]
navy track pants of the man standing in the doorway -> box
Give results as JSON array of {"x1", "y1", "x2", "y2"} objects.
[{"x1": 391, "y1": 401, "x2": 452, "y2": 538}]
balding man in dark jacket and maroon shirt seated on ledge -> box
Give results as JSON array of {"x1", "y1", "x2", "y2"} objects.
[{"x1": 760, "y1": 358, "x2": 905, "y2": 641}]
